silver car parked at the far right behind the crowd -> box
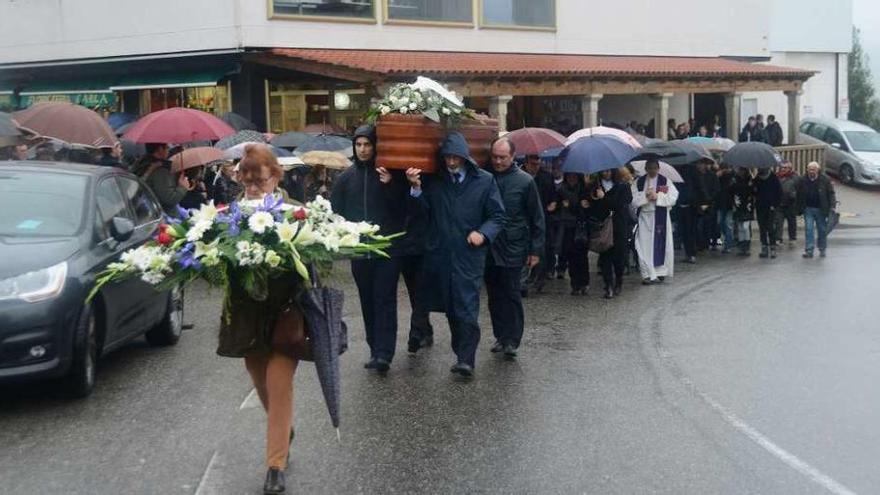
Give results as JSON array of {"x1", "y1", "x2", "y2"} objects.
[{"x1": 800, "y1": 118, "x2": 880, "y2": 185}]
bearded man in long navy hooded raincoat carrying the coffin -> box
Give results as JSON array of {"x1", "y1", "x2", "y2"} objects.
[{"x1": 406, "y1": 132, "x2": 504, "y2": 377}]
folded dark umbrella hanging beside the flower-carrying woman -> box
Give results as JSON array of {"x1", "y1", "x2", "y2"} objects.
[{"x1": 299, "y1": 268, "x2": 348, "y2": 438}]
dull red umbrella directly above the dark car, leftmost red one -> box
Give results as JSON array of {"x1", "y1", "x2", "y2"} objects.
[{"x1": 14, "y1": 102, "x2": 118, "y2": 148}]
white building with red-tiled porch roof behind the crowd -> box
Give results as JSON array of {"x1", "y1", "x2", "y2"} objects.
[{"x1": 0, "y1": 0, "x2": 852, "y2": 143}]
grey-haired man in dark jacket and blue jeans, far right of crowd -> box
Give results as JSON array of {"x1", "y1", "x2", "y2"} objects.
[{"x1": 797, "y1": 162, "x2": 837, "y2": 258}]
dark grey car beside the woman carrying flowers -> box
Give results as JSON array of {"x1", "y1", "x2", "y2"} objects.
[{"x1": 0, "y1": 161, "x2": 183, "y2": 397}]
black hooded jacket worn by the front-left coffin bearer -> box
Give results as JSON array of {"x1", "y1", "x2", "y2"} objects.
[{"x1": 330, "y1": 125, "x2": 407, "y2": 255}]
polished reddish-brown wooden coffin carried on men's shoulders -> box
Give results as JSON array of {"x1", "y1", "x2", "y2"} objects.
[{"x1": 376, "y1": 114, "x2": 498, "y2": 173}]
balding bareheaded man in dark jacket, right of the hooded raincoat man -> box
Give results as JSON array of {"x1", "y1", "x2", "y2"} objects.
[{"x1": 486, "y1": 138, "x2": 544, "y2": 359}]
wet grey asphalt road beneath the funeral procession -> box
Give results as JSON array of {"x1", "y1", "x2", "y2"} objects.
[{"x1": 0, "y1": 184, "x2": 880, "y2": 494}]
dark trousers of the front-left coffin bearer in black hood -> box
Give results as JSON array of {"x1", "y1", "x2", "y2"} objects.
[{"x1": 351, "y1": 258, "x2": 400, "y2": 362}]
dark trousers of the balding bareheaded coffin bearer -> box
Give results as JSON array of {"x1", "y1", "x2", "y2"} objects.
[{"x1": 485, "y1": 266, "x2": 524, "y2": 347}]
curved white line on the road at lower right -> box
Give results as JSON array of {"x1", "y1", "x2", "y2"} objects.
[{"x1": 651, "y1": 274, "x2": 856, "y2": 495}]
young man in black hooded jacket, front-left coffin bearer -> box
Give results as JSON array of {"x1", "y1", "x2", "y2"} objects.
[{"x1": 330, "y1": 125, "x2": 406, "y2": 373}]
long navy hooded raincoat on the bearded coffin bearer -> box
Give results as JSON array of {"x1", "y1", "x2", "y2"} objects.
[{"x1": 413, "y1": 132, "x2": 505, "y2": 314}]
